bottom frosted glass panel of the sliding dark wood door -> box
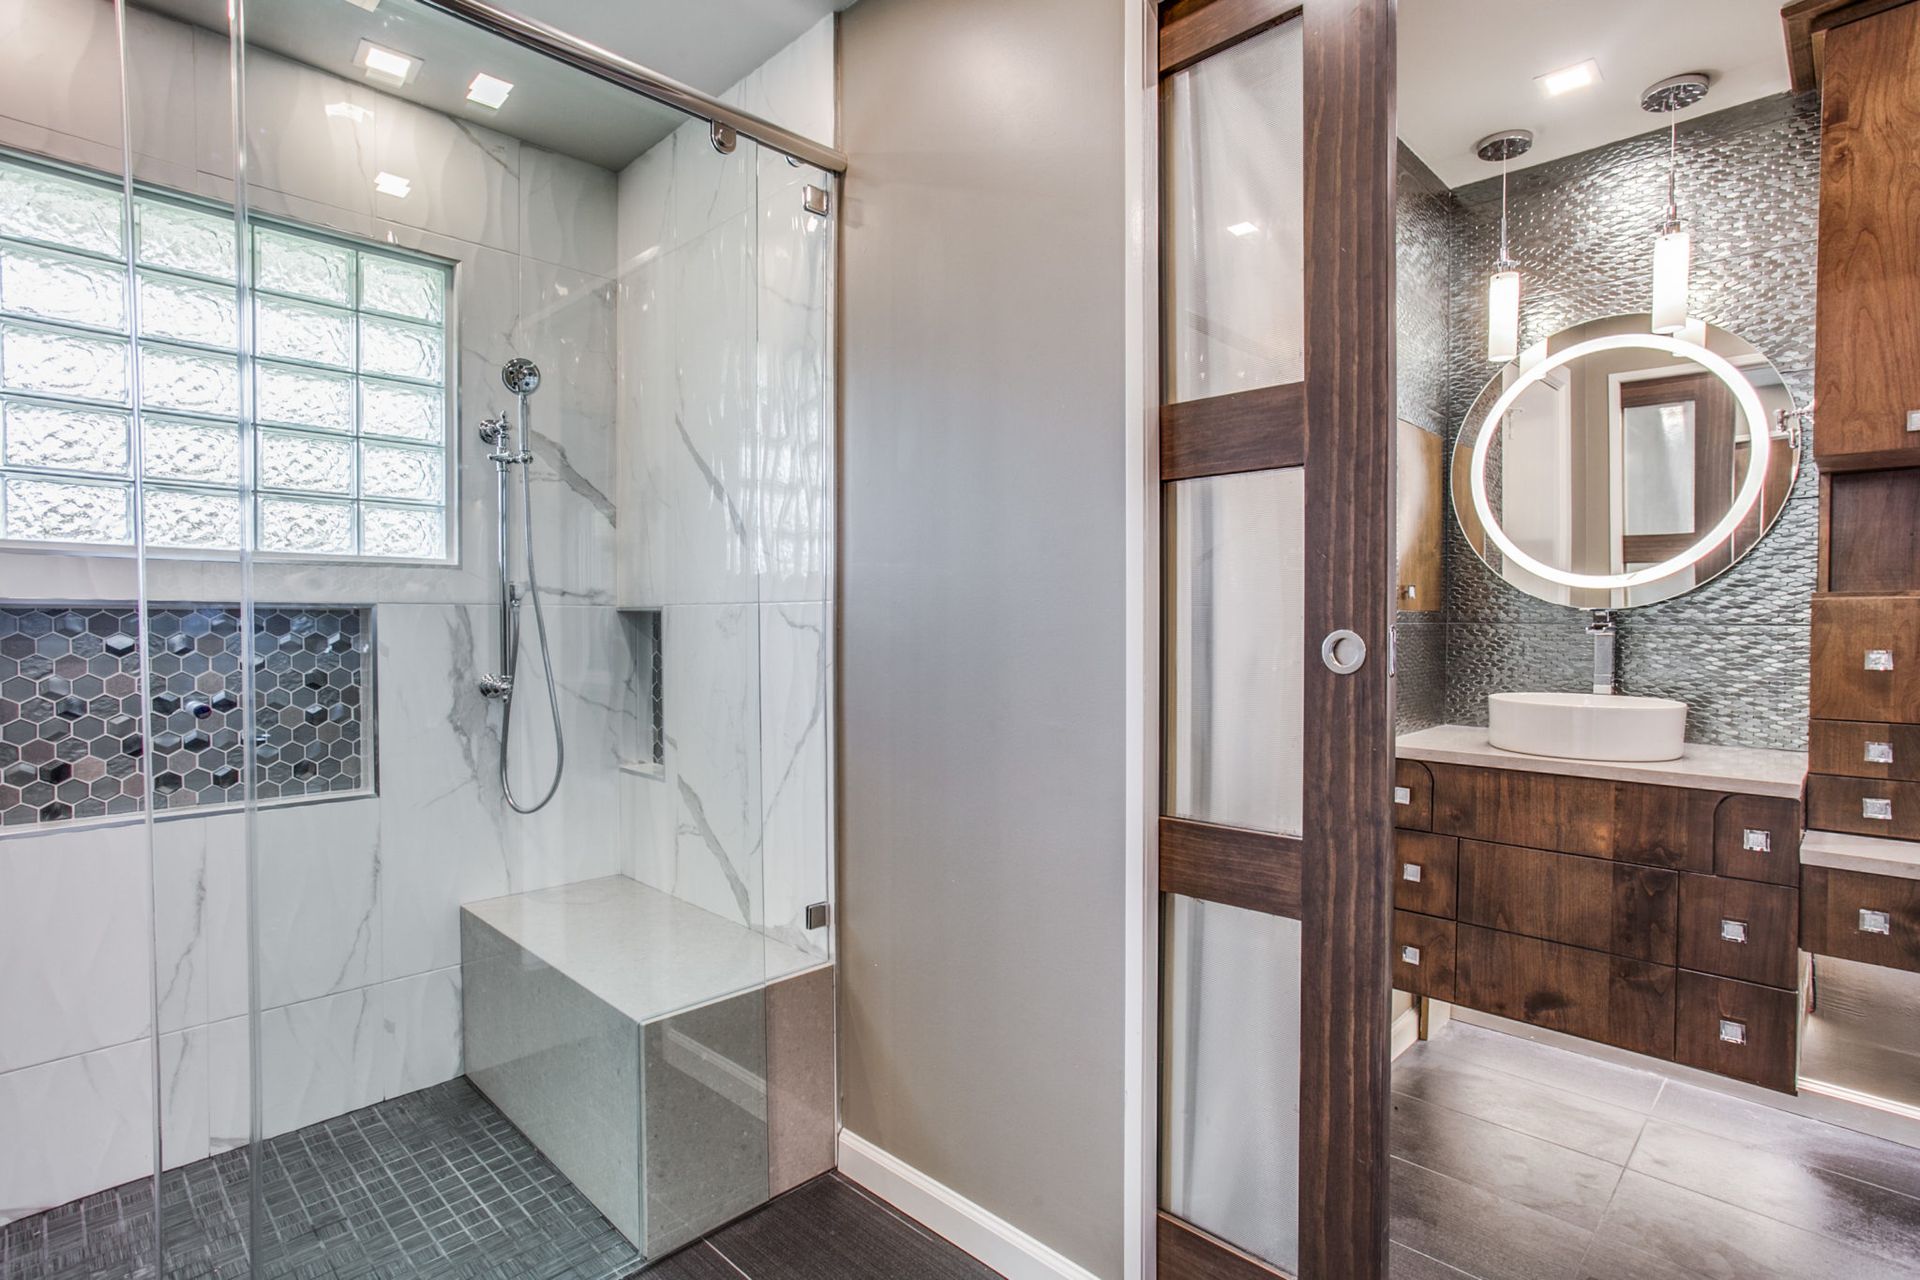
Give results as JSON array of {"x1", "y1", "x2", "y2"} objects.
[{"x1": 1160, "y1": 896, "x2": 1300, "y2": 1274}]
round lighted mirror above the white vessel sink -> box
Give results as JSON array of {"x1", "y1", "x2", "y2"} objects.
[{"x1": 1452, "y1": 315, "x2": 1799, "y2": 608}]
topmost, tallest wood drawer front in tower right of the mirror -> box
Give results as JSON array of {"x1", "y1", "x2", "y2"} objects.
[{"x1": 1811, "y1": 594, "x2": 1920, "y2": 723}]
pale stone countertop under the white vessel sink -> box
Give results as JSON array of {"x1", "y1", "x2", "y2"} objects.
[{"x1": 1396, "y1": 725, "x2": 1807, "y2": 800}]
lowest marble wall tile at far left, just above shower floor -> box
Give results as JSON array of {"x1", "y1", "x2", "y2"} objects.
[{"x1": 0, "y1": 1040, "x2": 154, "y2": 1222}]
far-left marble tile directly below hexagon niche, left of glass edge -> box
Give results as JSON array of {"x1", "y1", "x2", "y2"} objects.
[{"x1": 0, "y1": 823, "x2": 152, "y2": 1074}]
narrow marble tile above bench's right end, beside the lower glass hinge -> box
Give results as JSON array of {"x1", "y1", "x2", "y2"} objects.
[{"x1": 760, "y1": 603, "x2": 833, "y2": 954}]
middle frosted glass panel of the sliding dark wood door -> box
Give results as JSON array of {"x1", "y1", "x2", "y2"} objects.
[{"x1": 1165, "y1": 466, "x2": 1306, "y2": 835}]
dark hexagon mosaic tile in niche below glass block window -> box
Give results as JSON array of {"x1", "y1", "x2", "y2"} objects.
[{"x1": 0, "y1": 604, "x2": 372, "y2": 827}]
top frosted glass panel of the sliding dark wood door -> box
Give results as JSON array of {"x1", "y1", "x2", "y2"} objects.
[{"x1": 1165, "y1": 19, "x2": 1306, "y2": 401}]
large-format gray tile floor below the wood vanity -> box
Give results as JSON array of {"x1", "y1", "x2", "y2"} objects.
[{"x1": 1392, "y1": 1023, "x2": 1920, "y2": 1280}]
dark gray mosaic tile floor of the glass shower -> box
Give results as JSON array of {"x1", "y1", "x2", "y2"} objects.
[{"x1": 0, "y1": 1079, "x2": 639, "y2": 1280}]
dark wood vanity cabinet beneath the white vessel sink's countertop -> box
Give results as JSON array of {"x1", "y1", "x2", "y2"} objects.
[{"x1": 1394, "y1": 760, "x2": 1801, "y2": 1092}]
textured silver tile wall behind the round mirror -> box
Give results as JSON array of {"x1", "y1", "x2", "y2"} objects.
[{"x1": 1400, "y1": 94, "x2": 1820, "y2": 748}]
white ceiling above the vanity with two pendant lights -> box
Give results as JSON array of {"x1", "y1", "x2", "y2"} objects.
[{"x1": 1400, "y1": 0, "x2": 1788, "y2": 186}]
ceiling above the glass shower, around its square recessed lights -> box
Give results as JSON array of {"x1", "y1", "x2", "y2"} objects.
[{"x1": 132, "y1": 0, "x2": 852, "y2": 171}]
